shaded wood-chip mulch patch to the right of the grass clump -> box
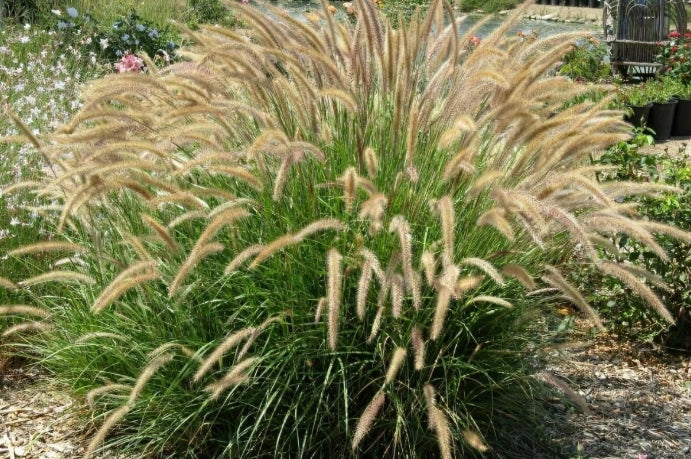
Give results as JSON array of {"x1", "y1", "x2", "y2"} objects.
[{"x1": 547, "y1": 337, "x2": 691, "y2": 459}]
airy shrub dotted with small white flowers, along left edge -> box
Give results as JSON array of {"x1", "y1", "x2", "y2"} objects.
[{"x1": 0, "y1": 26, "x2": 103, "y2": 312}]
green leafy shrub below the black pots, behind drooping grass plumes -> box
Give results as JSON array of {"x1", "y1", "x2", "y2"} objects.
[{"x1": 580, "y1": 132, "x2": 691, "y2": 349}]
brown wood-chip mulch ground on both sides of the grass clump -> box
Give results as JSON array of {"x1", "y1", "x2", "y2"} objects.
[{"x1": 0, "y1": 337, "x2": 691, "y2": 459}]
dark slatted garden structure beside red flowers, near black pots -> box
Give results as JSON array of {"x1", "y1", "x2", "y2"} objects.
[{"x1": 602, "y1": 0, "x2": 686, "y2": 76}]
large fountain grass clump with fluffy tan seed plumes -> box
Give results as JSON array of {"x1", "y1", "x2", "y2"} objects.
[{"x1": 5, "y1": 1, "x2": 688, "y2": 458}]
